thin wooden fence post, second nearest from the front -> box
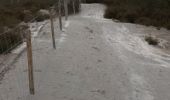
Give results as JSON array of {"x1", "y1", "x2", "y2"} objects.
[{"x1": 50, "y1": 8, "x2": 56, "y2": 49}]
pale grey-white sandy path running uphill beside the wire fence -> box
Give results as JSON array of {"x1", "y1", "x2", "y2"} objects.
[{"x1": 0, "y1": 4, "x2": 170, "y2": 100}]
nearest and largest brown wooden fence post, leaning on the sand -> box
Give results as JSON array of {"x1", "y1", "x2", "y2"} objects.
[{"x1": 25, "y1": 29, "x2": 35, "y2": 95}]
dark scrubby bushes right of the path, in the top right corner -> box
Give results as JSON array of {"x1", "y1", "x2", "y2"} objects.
[{"x1": 104, "y1": 0, "x2": 170, "y2": 29}]
